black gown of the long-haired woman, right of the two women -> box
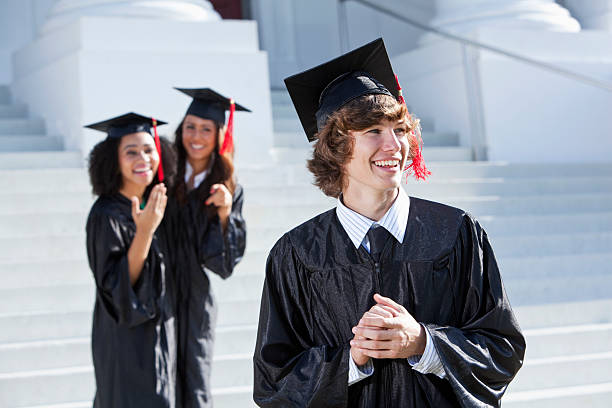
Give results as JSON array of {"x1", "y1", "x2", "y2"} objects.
[{"x1": 178, "y1": 183, "x2": 246, "y2": 408}]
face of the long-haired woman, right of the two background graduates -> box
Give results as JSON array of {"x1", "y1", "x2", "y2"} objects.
[{"x1": 183, "y1": 115, "x2": 218, "y2": 161}]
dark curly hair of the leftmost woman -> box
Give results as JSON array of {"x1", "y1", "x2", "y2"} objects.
[{"x1": 87, "y1": 137, "x2": 176, "y2": 198}]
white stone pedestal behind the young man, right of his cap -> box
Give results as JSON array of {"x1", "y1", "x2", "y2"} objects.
[{"x1": 392, "y1": 28, "x2": 612, "y2": 162}]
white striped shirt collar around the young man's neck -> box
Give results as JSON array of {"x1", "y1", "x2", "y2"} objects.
[{"x1": 336, "y1": 187, "x2": 410, "y2": 249}]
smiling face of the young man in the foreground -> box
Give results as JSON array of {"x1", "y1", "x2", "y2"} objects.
[{"x1": 343, "y1": 119, "x2": 409, "y2": 195}]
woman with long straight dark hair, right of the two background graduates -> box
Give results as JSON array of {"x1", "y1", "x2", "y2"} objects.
[{"x1": 174, "y1": 88, "x2": 248, "y2": 408}]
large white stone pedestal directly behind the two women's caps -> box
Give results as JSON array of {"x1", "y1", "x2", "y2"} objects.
[{"x1": 12, "y1": 17, "x2": 272, "y2": 166}]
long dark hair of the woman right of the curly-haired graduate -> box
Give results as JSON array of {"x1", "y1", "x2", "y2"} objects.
[{"x1": 174, "y1": 118, "x2": 236, "y2": 218}]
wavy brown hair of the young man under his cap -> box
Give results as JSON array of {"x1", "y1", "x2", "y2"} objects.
[{"x1": 307, "y1": 94, "x2": 419, "y2": 198}]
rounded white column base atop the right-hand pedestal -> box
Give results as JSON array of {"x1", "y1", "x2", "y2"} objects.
[{"x1": 430, "y1": 0, "x2": 580, "y2": 34}]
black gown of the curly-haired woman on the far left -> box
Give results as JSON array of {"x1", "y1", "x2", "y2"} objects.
[{"x1": 86, "y1": 194, "x2": 177, "y2": 408}]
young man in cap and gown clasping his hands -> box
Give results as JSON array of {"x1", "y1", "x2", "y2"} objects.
[{"x1": 253, "y1": 40, "x2": 525, "y2": 408}]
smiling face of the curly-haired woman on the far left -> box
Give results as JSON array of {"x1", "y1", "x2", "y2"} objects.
[{"x1": 118, "y1": 132, "x2": 159, "y2": 190}]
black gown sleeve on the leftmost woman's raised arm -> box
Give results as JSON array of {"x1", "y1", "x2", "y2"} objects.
[{"x1": 86, "y1": 209, "x2": 157, "y2": 327}]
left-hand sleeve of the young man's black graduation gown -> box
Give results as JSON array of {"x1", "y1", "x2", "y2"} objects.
[{"x1": 253, "y1": 235, "x2": 350, "y2": 407}]
